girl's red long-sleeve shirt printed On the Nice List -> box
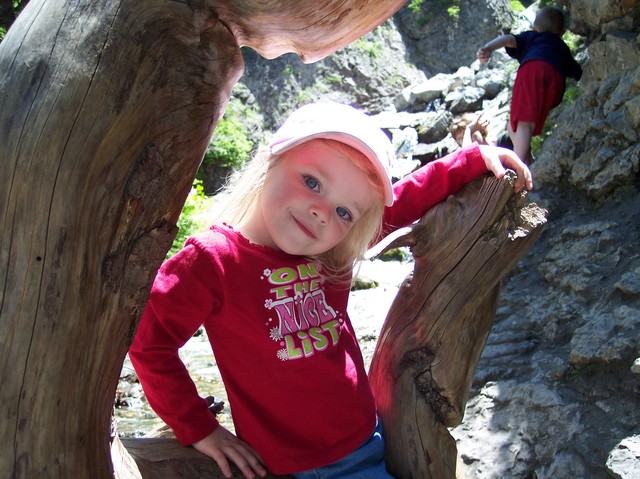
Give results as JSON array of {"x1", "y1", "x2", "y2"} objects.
[{"x1": 129, "y1": 146, "x2": 486, "y2": 474}]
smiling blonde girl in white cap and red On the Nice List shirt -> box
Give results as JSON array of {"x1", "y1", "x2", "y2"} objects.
[{"x1": 129, "y1": 103, "x2": 532, "y2": 478}]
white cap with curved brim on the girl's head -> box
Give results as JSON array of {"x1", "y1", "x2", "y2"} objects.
[{"x1": 269, "y1": 103, "x2": 394, "y2": 206}]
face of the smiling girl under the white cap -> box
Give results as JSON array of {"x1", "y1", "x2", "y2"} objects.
[{"x1": 238, "y1": 140, "x2": 381, "y2": 256}]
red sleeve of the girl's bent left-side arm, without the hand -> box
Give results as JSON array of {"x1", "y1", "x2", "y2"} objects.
[{"x1": 129, "y1": 247, "x2": 218, "y2": 446}]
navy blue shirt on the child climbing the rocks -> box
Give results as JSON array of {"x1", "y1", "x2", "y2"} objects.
[{"x1": 505, "y1": 30, "x2": 582, "y2": 80}]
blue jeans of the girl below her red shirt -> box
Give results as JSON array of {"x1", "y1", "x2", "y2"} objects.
[{"x1": 293, "y1": 420, "x2": 393, "y2": 479}]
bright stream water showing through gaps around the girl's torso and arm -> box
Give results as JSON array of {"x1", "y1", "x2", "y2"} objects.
[{"x1": 115, "y1": 260, "x2": 413, "y2": 437}]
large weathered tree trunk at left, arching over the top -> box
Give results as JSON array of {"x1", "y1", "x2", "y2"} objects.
[{"x1": 0, "y1": 0, "x2": 404, "y2": 478}]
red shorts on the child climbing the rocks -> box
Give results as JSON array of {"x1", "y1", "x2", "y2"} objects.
[{"x1": 510, "y1": 60, "x2": 565, "y2": 136}]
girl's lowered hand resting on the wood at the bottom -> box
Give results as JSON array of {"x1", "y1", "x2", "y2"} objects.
[{"x1": 193, "y1": 426, "x2": 267, "y2": 479}]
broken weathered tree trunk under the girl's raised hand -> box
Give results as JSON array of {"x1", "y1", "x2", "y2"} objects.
[{"x1": 369, "y1": 173, "x2": 546, "y2": 479}]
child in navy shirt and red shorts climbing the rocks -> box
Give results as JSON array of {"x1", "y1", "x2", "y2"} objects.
[{"x1": 477, "y1": 6, "x2": 582, "y2": 165}]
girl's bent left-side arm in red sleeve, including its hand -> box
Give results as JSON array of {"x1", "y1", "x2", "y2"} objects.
[{"x1": 129, "y1": 245, "x2": 266, "y2": 478}]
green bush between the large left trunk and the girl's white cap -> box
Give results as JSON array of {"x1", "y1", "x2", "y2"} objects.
[{"x1": 203, "y1": 99, "x2": 253, "y2": 168}]
